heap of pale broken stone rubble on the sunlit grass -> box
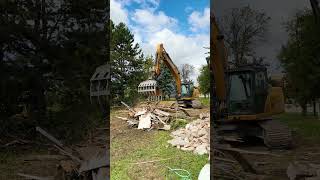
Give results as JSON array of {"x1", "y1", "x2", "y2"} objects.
[{"x1": 168, "y1": 114, "x2": 210, "y2": 155}]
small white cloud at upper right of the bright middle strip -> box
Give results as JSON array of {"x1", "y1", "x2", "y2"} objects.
[{"x1": 188, "y1": 8, "x2": 210, "y2": 32}]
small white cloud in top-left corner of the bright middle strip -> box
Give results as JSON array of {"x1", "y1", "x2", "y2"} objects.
[{"x1": 110, "y1": 0, "x2": 129, "y2": 24}]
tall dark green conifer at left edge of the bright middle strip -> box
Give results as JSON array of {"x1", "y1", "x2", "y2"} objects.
[{"x1": 110, "y1": 20, "x2": 145, "y2": 103}]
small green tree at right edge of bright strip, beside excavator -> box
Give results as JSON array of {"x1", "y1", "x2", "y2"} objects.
[{"x1": 198, "y1": 65, "x2": 210, "y2": 96}]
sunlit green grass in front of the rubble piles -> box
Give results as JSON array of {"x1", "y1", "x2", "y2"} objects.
[{"x1": 111, "y1": 131, "x2": 208, "y2": 180}]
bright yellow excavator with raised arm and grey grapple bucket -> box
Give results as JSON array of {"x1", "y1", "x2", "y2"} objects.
[{"x1": 138, "y1": 44, "x2": 201, "y2": 108}]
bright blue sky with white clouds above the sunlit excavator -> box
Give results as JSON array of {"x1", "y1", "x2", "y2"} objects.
[{"x1": 110, "y1": 0, "x2": 210, "y2": 82}]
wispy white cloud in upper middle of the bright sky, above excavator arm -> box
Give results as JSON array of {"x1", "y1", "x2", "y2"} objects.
[{"x1": 131, "y1": 9, "x2": 178, "y2": 32}]
